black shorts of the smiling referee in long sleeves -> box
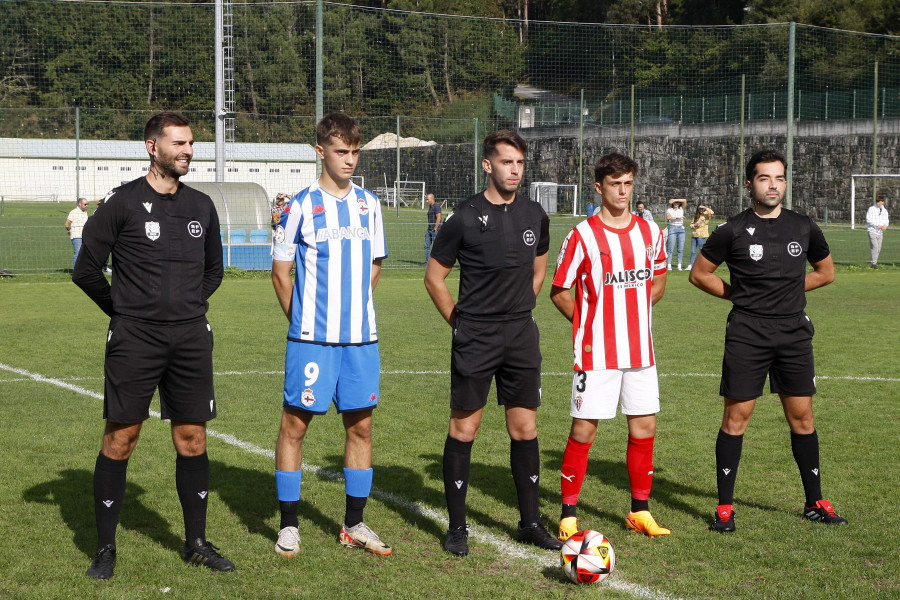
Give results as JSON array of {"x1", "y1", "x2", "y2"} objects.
[{"x1": 103, "y1": 316, "x2": 216, "y2": 425}]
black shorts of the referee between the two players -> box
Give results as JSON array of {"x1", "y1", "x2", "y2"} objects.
[{"x1": 450, "y1": 316, "x2": 541, "y2": 410}]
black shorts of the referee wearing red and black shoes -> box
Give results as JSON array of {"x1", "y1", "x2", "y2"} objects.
[{"x1": 719, "y1": 311, "x2": 816, "y2": 401}]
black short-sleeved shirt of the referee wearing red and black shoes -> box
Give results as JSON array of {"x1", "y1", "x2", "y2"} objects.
[{"x1": 702, "y1": 208, "x2": 831, "y2": 317}]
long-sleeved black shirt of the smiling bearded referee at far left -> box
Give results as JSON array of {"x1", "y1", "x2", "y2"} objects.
[{"x1": 72, "y1": 177, "x2": 223, "y2": 323}]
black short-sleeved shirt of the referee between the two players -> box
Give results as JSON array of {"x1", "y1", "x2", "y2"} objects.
[{"x1": 431, "y1": 192, "x2": 550, "y2": 321}]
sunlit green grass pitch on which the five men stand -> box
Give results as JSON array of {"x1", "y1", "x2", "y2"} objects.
[{"x1": 0, "y1": 268, "x2": 900, "y2": 599}]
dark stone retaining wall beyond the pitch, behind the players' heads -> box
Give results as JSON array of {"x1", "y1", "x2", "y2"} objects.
[{"x1": 357, "y1": 119, "x2": 900, "y2": 221}]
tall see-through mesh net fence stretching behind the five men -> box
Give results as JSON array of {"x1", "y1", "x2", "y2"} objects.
[{"x1": 0, "y1": 1, "x2": 900, "y2": 272}]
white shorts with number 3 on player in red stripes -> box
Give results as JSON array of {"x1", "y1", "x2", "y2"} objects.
[{"x1": 569, "y1": 365, "x2": 659, "y2": 419}]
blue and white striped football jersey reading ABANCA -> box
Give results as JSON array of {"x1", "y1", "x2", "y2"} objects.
[{"x1": 272, "y1": 183, "x2": 387, "y2": 345}]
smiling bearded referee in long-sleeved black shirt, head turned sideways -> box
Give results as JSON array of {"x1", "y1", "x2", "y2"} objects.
[{"x1": 72, "y1": 112, "x2": 234, "y2": 579}]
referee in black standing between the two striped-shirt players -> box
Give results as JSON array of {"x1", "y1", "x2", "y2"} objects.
[{"x1": 425, "y1": 130, "x2": 562, "y2": 556}]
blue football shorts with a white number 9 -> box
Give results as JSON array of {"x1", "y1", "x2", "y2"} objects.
[{"x1": 284, "y1": 340, "x2": 381, "y2": 415}]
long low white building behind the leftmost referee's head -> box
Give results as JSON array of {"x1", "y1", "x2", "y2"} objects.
[{"x1": 0, "y1": 138, "x2": 316, "y2": 202}]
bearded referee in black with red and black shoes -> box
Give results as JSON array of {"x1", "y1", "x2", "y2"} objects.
[{"x1": 690, "y1": 150, "x2": 847, "y2": 532}]
